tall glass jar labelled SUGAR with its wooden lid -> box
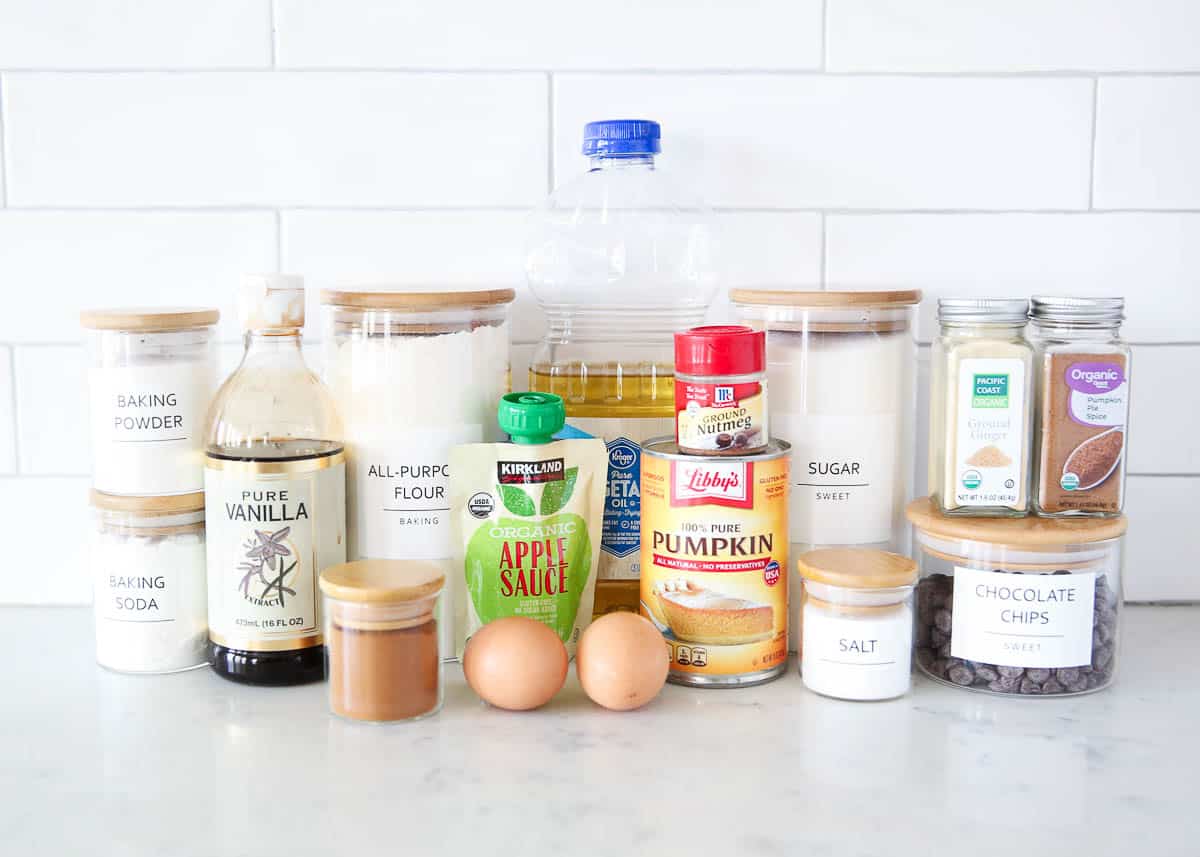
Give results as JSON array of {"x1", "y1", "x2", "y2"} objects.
[{"x1": 730, "y1": 289, "x2": 920, "y2": 651}]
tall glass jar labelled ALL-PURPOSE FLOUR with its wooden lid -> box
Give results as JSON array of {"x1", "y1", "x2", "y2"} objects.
[{"x1": 320, "y1": 289, "x2": 515, "y2": 652}]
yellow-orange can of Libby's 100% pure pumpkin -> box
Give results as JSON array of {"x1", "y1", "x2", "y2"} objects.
[{"x1": 642, "y1": 438, "x2": 791, "y2": 687}]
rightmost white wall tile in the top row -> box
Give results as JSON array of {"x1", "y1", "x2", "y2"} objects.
[{"x1": 827, "y1": 0, "x2": 1200, "y2": 72}]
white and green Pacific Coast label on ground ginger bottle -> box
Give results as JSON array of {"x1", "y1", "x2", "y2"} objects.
[{"x1": 954, "y1": 358, "x2": 1028, "y2": 507}]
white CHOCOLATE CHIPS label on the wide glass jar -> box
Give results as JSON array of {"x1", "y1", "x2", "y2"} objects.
[{"x1": 950, "y1": 565, "x2": 1096, "y2": 669}]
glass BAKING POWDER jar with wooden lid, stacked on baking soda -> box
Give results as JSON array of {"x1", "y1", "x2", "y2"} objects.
[{"x1": 80, "y1": 308, "x2": 221, "y2": 496}]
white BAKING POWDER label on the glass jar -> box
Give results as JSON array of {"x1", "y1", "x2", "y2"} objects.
[{"x1": 89, "y1": 360, "x2": 216, "y2": 495}]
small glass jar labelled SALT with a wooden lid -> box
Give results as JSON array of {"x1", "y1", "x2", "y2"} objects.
[{"x1": 797, "y1": 547, "x2": 917, "y2": 700}]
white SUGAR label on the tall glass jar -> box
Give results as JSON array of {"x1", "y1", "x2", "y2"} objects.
[{"x1": 773, "y1": 414, "x2": 905, "y2": 545}]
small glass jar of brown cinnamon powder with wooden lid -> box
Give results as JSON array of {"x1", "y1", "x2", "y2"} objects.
[{"x1": 320, "y1": 559, "x2": 445, "y2": 723}]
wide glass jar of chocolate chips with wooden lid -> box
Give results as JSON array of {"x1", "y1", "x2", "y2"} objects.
[{"x1": 907, "y1": 498, "x2": 1128, "y2": 696}]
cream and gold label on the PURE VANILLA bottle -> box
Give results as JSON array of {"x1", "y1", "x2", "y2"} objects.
[{"x1": 204, "y1": 451, "x2": 346, "y2": 652}]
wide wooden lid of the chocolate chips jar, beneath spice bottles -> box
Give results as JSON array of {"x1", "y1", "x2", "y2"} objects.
[{"x1": 905, "y1": 497, "x2": 1129, "y2": 550}]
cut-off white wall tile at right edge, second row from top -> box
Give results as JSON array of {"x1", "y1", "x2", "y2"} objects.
[{"x1": 1096, "y1": 76, "x2": 1200, "y2": 209}]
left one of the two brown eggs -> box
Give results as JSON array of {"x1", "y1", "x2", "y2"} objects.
[{"x1": 462, "y1": 616, "x2": 566, "y2": 712}]
